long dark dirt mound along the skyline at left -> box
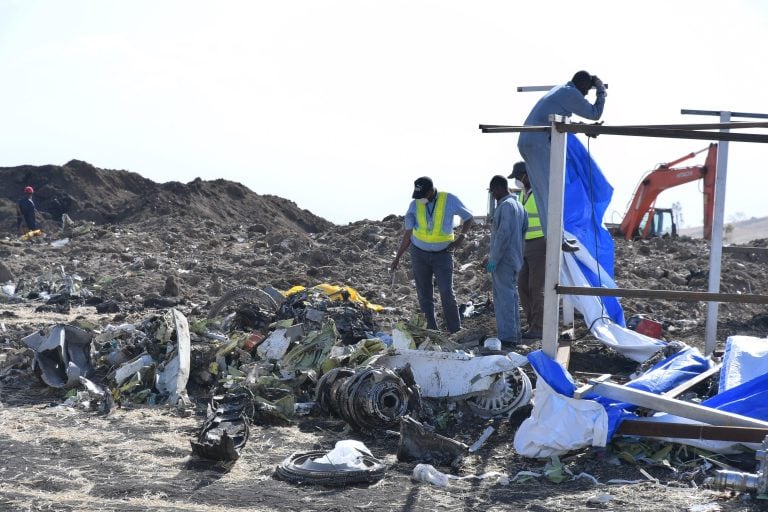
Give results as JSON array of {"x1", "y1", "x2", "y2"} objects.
[{"x1": 0, "y1": 160, "x2": 332, "y2": 233}]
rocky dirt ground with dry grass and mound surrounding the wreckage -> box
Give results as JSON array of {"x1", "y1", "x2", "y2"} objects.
[{"x1": 0, "y1": 161, "x2": 768, "y2": 511}]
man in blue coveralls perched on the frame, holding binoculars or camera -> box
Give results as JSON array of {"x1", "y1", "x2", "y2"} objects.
[{"x1": 517, "y1": 71, "x2": 606, "y2": 246}]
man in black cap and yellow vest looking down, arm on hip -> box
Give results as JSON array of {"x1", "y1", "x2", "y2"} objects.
[{"x1": 389, "y1": 176, "x2": 473, "y2": 333}]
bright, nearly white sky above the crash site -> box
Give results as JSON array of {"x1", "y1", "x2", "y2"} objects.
[{"x1": 0, "y1": 0, "x2": 768, "y2": 227}]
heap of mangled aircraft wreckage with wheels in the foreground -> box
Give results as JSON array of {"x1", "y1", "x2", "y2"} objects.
[{"x1": 6, "y1": 284, "x2": 531, "y2": 485}]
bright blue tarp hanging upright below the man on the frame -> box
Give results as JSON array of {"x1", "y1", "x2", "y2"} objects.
[{"x1": 563, "y1": 133, "x2": 625, "y2": 327}]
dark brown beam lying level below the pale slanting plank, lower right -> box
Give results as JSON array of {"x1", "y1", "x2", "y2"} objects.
[{"x1": 616, "y1": 419, "x2": 768, "y2": 443}]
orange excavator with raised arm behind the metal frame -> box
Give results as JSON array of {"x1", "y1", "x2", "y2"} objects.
[{"x1": 606, "y1": 143, "x2": 717, "y2": 240}]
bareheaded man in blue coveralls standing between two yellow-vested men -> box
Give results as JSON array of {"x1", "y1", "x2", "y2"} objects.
[{"x1": 485, "y1": 176, "x2": 528, "y2": 345}]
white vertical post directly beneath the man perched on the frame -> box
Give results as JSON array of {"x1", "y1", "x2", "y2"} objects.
[{"x1": 541, "y1": 116, "x2": 568, "y2": 358}]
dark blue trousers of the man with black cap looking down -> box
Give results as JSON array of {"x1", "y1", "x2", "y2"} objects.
[{"x1": 411, "y1": 244, "x2": 461, "y2": 333}]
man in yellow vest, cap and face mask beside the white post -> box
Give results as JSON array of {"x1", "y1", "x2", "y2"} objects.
[{"x1": 509, "y1": 162, "x2": 547, "y2": 339}]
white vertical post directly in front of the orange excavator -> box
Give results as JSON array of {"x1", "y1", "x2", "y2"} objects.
[{"x1": 704, "y1": 112, "x2": 731, "y2": 356}]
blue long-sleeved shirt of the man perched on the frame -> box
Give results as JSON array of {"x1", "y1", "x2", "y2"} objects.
[{"x1": 521, "y1": 82, "x2": 605, "y2": 128}]
